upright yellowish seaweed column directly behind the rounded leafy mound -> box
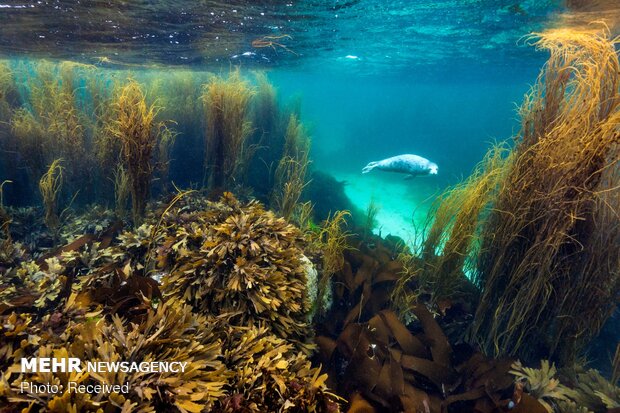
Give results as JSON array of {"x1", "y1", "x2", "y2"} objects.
[{"x1": 202, "y1": 70, "x2": 256, "y2": 188}]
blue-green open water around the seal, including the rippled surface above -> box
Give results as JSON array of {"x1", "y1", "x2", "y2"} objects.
[{"x1": 0, "y1": 1, "x2": 592, "y2": 241}]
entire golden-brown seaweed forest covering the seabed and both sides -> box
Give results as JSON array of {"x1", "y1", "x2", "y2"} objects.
[{"x1": 0, "y1": 25, "x2": 620, "y2": 413}]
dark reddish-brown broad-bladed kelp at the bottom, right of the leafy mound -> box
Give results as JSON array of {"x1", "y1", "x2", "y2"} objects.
[{"x1": 315, "y1": 233, "x2": 544, "y2": 413}]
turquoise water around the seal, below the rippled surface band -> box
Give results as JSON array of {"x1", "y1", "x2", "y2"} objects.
[{"x1": 270, "y1": 69, "x2": 539, "y2": 240}]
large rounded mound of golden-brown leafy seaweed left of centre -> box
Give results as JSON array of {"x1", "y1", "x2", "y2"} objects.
[{"x1": 156, "y1": 193, "x2": 310, "y2": 347}]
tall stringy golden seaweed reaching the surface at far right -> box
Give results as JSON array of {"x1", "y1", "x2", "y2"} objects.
[{"x1": 473, "y1": 25, "x2": 620, "y2": 365}]
